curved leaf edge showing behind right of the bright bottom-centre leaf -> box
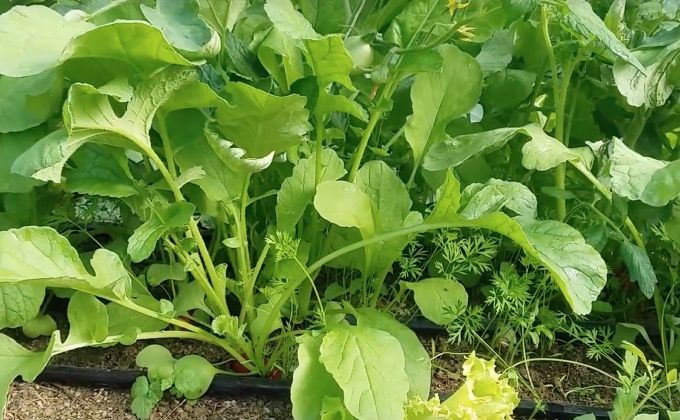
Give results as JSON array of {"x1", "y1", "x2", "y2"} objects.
[{"x1": 356, "y1": 308, "x2": 432, "y2": 400}]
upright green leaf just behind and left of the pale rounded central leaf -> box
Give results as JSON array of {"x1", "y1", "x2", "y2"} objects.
[{"x1": 276, "y1": 149, "x2": 347, "y2": 232}]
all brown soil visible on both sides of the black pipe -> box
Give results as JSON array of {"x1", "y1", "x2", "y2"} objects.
[{"x1": 5, "y1": 334, "x2": 624, "y2": 420}]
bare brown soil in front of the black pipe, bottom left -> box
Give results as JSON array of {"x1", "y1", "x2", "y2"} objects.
[{"x1": 4, "y1": 383, "x2": 292, "y2": 420}]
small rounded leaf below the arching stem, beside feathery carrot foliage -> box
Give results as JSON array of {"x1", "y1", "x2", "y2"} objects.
[{"x1": 401, "y1": 278, "x2": 468, "y2": 325}]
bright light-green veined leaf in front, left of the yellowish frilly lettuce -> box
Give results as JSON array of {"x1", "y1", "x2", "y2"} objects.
[{"x1": 319, "y1": 326, "x2": 409, "y2": 420}]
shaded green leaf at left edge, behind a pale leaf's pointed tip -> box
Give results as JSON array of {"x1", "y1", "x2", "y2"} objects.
[{"x1": 0, "y1": 127, "x2": 45, "y2": 193}]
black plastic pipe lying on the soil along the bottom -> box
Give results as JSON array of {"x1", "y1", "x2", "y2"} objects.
[{"x1": 36, "y1": 365, "x2": 609, "y2": 420}]
